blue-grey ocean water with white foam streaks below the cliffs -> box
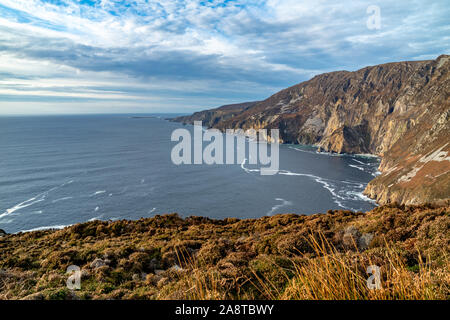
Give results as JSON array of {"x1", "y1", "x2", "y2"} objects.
[{"x1": 0, "y1": 114, "x2": 379, "y2": 233}]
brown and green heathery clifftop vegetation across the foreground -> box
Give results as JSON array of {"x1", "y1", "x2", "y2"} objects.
[{"x1": 0, "y1": 205, "x2": 450, "y2": 299}]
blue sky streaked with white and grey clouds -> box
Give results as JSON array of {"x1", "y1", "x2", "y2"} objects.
[{"x1": 0, "y1": 0, "x2": 450, "y2": 115}]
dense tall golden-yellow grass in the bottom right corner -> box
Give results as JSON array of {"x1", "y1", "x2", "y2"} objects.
[{"x1": 277, "y1": 238, "x2": 450, "y2": 300}]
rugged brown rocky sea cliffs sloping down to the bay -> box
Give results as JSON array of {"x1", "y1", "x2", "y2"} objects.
[{"x1": 172, "y1": 55, "x2": 450, "y2": 204}]
